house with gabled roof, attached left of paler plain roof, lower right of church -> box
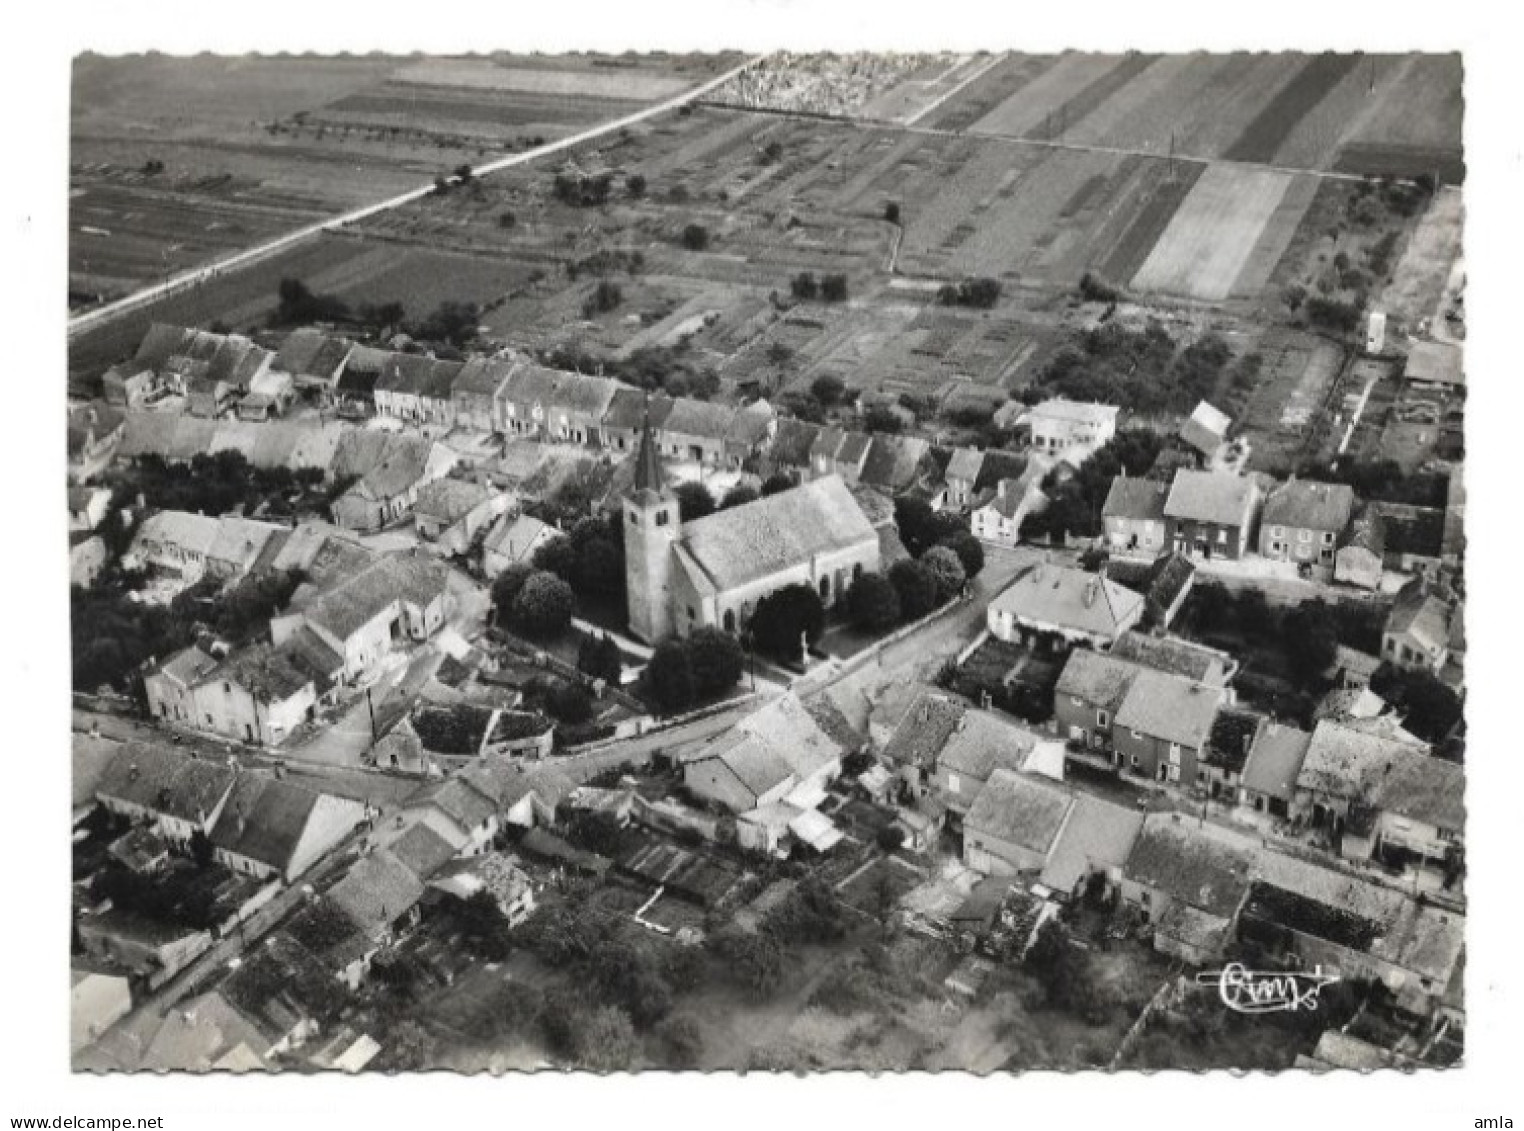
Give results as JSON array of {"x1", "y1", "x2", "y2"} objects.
[{"x1": 963, "y1": 770, "x2": 1074, "y2": 875}]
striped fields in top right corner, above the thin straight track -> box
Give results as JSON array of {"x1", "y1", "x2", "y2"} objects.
[{"x1": 922, "y1": 52, "x2": 1465, "y2": 183}]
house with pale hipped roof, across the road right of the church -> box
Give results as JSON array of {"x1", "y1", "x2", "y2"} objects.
[{"x1": 986, "y1": 562, "x2": 1143, "y2": 648}]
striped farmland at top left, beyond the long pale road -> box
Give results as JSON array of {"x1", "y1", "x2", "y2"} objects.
[{"x1": 69, "y1": 55, "x2": 738, "y2": 306}]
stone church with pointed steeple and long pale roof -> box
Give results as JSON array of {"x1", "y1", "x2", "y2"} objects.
[{"x1": 623, "y1": 427, "x2": 879, "y2": 643}]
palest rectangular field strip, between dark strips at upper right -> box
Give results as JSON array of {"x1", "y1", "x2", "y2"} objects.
[{"x1": 1132, "y1": 166, "x2": 1292, "y2": 302}]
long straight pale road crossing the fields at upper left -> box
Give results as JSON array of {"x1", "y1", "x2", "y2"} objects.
[{"x1": 69, "y1": 55, "x2": 764, "y2": 338}]
